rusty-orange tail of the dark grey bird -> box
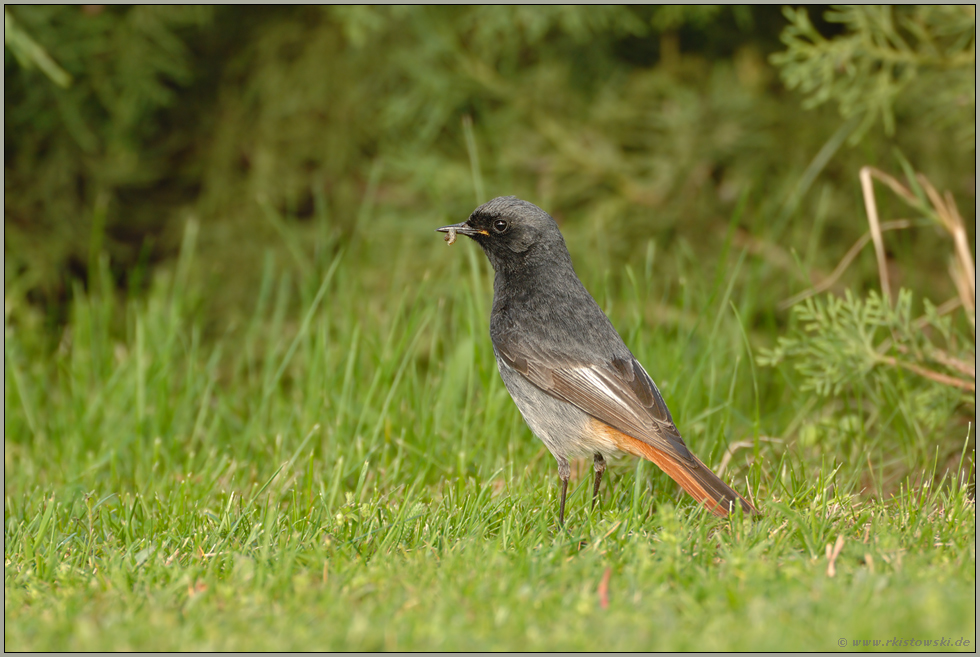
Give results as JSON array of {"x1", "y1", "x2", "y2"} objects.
[{"x1": 617, "y1": 434, "x2": 759, "y2": 517}]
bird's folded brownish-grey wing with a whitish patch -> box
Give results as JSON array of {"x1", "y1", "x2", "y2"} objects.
[{"x1": 494, "y1": 336, "x2": 694, "y2": 461}]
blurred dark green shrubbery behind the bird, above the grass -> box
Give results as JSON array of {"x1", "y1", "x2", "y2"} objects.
[{"x1": 4, "y1": 5, "x2": 975, "y2": 482}]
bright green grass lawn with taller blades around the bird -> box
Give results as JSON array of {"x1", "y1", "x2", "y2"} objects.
[{"x1": 4, "y1": 208, "x2": 976, "y2": 651}]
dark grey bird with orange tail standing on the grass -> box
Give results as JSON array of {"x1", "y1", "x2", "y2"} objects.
[{"x1": 436, "y1": 196, "x2": 759, "y2": 527}]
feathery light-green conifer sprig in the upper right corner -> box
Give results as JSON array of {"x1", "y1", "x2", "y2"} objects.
[{"x1": 772, "y1": 5, "x2": 976, "y2": 144}]
